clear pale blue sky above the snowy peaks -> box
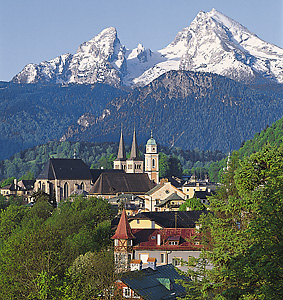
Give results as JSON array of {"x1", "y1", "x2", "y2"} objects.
[{"x1": 0, "y1": 0, "x2": 283, "y2": 81}]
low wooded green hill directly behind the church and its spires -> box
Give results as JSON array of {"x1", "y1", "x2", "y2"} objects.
[{"x1": 0, "y1": 141, "x2": 226, "y2": 180}]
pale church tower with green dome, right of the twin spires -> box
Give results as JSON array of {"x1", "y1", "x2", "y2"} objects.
[{"x1": 144, "y1": 132, "x2": 159, "y2": 183}]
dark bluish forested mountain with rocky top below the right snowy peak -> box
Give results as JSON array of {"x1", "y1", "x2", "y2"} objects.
[{"x1": 61, "y1": 71, "x2": 283, "y2": 152}]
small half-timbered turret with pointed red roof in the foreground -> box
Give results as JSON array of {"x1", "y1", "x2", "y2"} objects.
[{"x1": 111, "y1": 209, "x2": 136, "y2": 272}]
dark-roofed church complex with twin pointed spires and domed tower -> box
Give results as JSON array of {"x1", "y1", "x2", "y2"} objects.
[{"x1": 34, "y1": 130, "x2": 159, "y2": 203}]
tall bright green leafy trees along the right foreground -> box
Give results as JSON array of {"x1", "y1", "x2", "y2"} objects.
[{"x1": 186, "y1": 144, "x2": 283, "y2": 300}]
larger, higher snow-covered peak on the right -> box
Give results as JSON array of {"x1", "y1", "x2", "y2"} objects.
[{"x1": 134, "y1": 9, "x2": 283, "y2": 85}]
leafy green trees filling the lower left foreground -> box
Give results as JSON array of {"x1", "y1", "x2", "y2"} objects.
[{"x1": 0, "y1": 196, "x2": 121, "y2": 300}]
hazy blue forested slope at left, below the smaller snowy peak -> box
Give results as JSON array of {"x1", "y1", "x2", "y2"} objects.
[{"x1": 0, "y1": 82, "x2": 126, "y2": 160}]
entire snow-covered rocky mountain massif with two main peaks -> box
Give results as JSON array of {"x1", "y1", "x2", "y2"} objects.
[{"x1": 13, "y1": 9, "x2": 283, "y2": 86}]
